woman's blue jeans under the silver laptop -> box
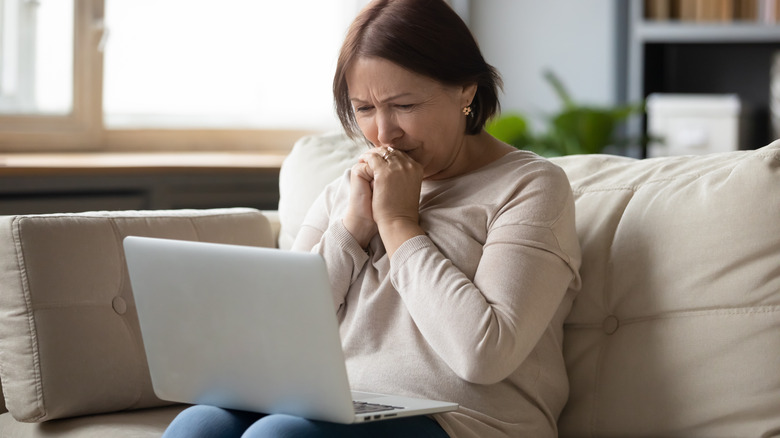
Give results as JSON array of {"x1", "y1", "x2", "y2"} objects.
[{"x1": 163, "y1": 405, "x2": 448, "y2": 438}]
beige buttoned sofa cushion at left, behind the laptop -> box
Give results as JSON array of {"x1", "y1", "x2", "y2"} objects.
[{"x1": 0, "y1": 209, "x2": 273, "y2": 422}]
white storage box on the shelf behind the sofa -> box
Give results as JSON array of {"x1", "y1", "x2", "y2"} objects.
[{"x1": 647, "y1": 93, "x2": 743, "y2": 158}]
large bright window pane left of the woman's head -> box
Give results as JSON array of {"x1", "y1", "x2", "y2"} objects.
[{"x1": 103, "y1": 0, "x2": 356, "y2": 129}]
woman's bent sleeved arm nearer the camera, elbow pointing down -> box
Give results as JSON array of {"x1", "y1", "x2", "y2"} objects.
[{"x1": 391, "y1": 169, "x2": 579, "y2": 384}]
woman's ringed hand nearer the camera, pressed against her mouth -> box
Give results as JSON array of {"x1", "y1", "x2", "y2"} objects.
[{"x1": 360, "y1": 147, "x2": 425, "y2": 256}]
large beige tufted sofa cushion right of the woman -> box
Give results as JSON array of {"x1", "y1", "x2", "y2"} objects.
[{"x1": 554, "y1": 142, "x2": 780, "y2": 437}]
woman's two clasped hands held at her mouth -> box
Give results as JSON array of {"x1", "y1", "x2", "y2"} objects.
[{"x1": 342, "y1": 147, "x2": 424, "y2": 256}]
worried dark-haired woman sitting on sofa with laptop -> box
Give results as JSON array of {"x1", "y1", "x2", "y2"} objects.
[{"x1": 167, "y1": 0, "x2": 580, "y2": 438}]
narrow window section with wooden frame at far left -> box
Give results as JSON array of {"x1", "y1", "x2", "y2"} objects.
[{"x1": 0, "y1": 0, "x2": 103, "y2": 152}]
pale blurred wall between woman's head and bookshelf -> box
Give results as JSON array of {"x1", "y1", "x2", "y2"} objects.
[{"x1": 469, "y1": 0, "x2": 621, "y2": 126}]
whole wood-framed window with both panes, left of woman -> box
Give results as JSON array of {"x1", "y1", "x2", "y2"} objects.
[{"x1": 0, "y1": 0, "x2": 366, "y2": 152}]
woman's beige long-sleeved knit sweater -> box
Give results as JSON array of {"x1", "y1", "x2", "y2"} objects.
[{"x1": 294, "y1": 151, "x2": 580, "y2": 438}]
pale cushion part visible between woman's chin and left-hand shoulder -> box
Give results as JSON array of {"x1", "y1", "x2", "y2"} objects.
[{"x1": 278, "y1": 132, "x2": 368, "y2": 249}]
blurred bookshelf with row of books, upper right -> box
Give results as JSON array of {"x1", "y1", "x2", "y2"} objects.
[{"x1": 625, "y1": 0, "x2": 780, "y2": 153}]
